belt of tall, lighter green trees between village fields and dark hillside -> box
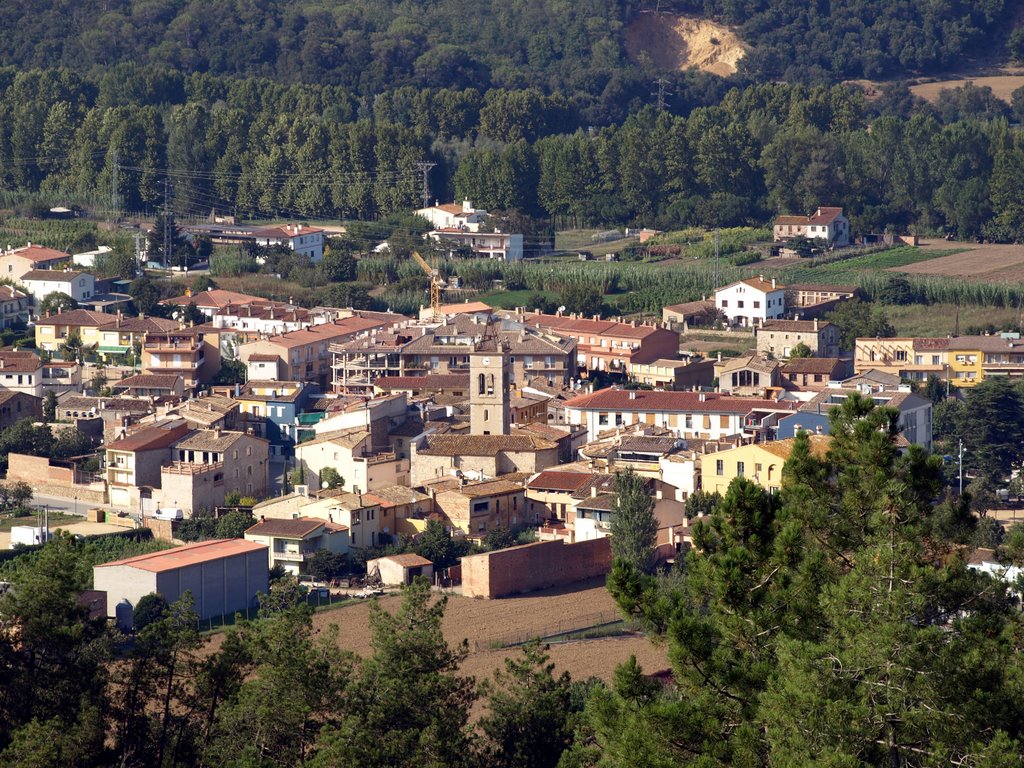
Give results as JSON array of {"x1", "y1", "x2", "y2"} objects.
[{"x1": 0, "y1": 68, "x2": 1024, "y2": 241}]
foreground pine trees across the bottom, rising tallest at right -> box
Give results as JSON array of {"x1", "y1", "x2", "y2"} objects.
[{"x1": 0, "y1": 397, "x2": 1024, "y2": 768}]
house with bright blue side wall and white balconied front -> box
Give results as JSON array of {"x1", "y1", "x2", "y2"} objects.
[{"x1": 234, "y1": 381, "x2": 314, "y2": 458}]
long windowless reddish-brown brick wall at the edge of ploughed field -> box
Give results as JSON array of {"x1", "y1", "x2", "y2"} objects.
[{"x1": 462, "y1": 538, "x2": 611, "y2": 598}]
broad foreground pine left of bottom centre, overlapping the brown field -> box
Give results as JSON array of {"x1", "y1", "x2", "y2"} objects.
[{"x1": 309, "y1": 578, "x2": 476, "y2": 768}]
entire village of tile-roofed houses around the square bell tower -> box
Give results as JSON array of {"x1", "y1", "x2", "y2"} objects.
[{"x1": 0, "y1": 202, "x2": 1007, "y2": 629}]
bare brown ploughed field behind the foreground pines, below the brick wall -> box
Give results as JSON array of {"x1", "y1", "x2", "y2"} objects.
[{"x1": 205, "y1": 580, "x2": 669, "y2": 692}]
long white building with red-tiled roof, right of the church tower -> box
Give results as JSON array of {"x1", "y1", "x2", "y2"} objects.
[{"x1": 565, "y1": 388, "x2": 798, "y2": 440}]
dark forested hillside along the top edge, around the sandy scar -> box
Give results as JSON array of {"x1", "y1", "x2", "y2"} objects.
[{"x1": 0, "y1": 0, "x2": 1016, "y2": 92}]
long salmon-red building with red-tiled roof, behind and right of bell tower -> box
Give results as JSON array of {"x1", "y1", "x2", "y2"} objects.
[{"x1": 497, "y1": 310, "x2": 679, "y2": 376}]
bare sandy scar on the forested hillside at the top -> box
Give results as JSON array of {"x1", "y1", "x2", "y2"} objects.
[{"x1": 625, "y1": 11, "x2": 748, "y2": 77}]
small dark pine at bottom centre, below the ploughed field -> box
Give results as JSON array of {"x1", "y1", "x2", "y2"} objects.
[{"x1": 479, "y1": 640, "x2": 578, "y2": 768}]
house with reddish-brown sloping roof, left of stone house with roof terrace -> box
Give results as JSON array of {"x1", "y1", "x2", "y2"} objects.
[{"x1": 105, "y1": 419, "x2": 191, "y2": 509}]
